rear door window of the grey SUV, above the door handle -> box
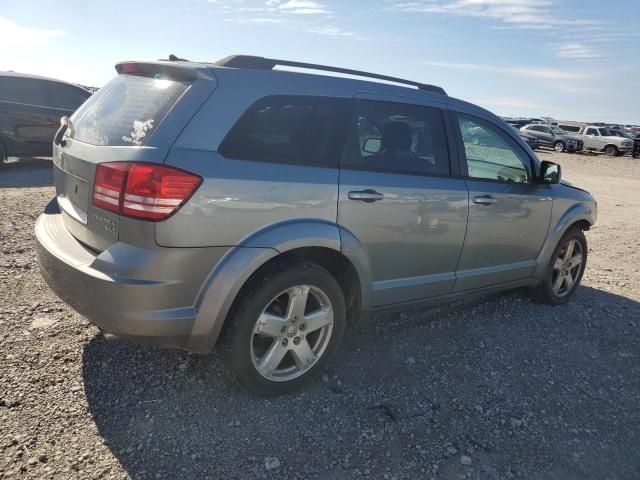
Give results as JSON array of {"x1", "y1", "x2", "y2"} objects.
[{"x1": 342, "y1": 100, "x2": 449, "y2": 175}]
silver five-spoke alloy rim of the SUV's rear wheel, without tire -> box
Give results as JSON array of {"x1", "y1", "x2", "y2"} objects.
[{"x1": 250, "y1": 285, "x2": 334, "y2": 382}]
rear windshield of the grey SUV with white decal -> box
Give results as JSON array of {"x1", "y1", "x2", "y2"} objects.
[{"x1": 71, "y1": 75, "x2": 189, "y2": 146}]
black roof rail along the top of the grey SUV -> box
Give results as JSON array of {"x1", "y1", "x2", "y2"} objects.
[{"x1": 214, "y1": 55, "x2": 447, "y2": 95}]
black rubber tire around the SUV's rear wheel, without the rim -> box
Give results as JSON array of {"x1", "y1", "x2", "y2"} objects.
[{"x1": 228, "y1": 263, "x2": 346, "y2": 397}]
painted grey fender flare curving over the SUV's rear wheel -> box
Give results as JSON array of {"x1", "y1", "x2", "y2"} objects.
[{"x1": 187, "y1": 219, "x2": 372, "y2": 353}]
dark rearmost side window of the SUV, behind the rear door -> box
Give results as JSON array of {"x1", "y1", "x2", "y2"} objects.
[{"x1": 218, "y1": 95, "x2": 351, "y2": 167}]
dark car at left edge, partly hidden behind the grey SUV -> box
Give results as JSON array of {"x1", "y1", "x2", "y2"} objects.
[{"x1": 0, "y1": 72, "x2": 91, "y2": 163}]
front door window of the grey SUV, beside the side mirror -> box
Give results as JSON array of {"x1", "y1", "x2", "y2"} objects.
[{"x1": 458, "y1": 114, "x2": 532, "y2": 183}]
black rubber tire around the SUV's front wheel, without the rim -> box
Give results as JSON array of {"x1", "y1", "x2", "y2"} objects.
[{"x1": 530, "y1": 227, "x2": 587, "y2": 305}]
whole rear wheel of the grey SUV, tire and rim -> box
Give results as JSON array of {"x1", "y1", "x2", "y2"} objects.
[{"x1": 231, "y1": 263, "x2": 346, "y2": 396}]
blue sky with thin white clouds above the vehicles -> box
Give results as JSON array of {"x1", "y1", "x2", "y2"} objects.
[{"x1": 0, "y1": 0, "x2": 640, "y2": 124}]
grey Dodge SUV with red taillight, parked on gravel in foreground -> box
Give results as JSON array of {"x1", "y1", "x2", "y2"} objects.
[{"x1": 35, "y1": 56, "x2": 596, "y2": 395}]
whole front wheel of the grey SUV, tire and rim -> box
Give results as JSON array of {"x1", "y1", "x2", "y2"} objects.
[{"x1": 531, "y1": 227, "x2": 587, "y2": 305}]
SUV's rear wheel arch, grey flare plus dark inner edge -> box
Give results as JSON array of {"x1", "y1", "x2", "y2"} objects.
[{"x1": 188, "y1": 220, "x2": 372, "y2": 353}]
